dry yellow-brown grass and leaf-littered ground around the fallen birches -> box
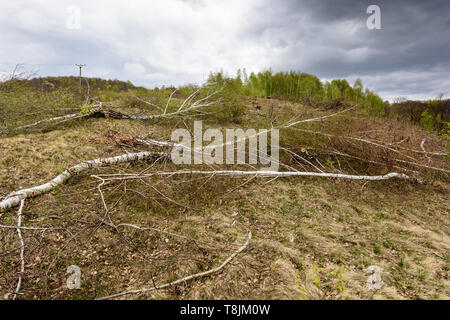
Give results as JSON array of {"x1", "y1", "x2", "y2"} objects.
[{"x1": 0, "y1": 92, "x2": 450, "y2": 299}]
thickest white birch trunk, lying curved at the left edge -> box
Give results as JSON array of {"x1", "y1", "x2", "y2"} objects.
[{"x1": 0, "y1": 152, "x2": 165, "y2": 211}]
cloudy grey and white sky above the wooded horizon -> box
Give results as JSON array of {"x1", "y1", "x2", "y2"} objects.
[{"x1": 0, "y1": 0, "x2": 450, "y2": 99}]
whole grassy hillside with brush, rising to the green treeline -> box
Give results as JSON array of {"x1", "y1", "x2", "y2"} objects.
[{"x1": 0, "y1": 75, "x2": 450, "y2": 299}]
